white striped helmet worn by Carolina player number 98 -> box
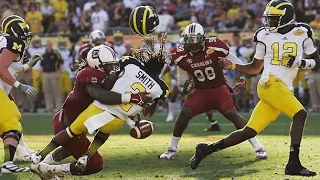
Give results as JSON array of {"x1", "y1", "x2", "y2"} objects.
[{"x1": 183, "y1": 23, "x2": 205, "y2": 53}]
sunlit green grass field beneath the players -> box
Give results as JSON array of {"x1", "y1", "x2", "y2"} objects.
[{"x1": 0, "y1": 114, "x2": 320, "y2": 180}]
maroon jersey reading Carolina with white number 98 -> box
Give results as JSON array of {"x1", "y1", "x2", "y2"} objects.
[{"x1": 171, "y1": 37, "x2": 229, "y2": 89}]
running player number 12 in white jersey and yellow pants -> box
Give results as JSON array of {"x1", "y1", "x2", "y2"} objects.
[{"x1": 190, "y1": 0, "x2": 320, "y2": 176}]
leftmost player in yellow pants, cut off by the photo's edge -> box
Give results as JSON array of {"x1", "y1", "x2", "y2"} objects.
[{"x1": 0, "y1": 15, "x2": 42, "y2": 173}]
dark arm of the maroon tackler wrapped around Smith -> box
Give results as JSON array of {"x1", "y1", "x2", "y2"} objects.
[{"x1": 86, "y1": 84, "x2": 122, "y2": 105}]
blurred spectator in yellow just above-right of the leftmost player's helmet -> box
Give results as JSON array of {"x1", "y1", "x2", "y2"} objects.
[{"x1": 25, "y1": 4, "x2": 43, "y2": 34}]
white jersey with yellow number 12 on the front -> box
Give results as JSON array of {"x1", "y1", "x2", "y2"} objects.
[{"x1": 254, "y1": 23, "x2": 317, "y2": 87}]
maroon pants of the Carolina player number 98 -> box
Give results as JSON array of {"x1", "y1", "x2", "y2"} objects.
[{"x1": 182, "y1": 85, "x2": 236, "y2": 116}]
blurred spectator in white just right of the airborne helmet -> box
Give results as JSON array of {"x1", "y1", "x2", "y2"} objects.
[{"x1": 156, "y1": 6, "x2": 174, "y2": 33}]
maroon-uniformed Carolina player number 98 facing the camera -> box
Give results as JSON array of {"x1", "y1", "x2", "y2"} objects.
[{"x1": 159, "y1": 23, "x2": 267, "y2": 159}]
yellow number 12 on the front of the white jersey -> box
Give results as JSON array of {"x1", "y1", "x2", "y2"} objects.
[{"x1": 271, "y1": 42, "x2": 298, "y2": 66}]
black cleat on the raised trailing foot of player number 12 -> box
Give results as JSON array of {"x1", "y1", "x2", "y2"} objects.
[{"x1": 189, "y1": 143, "x2": 209, "y2": 170}]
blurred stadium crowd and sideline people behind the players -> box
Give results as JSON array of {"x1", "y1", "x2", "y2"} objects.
[{"x1": 0, "y1": 0, "x2": 320, "y2": 112}]
